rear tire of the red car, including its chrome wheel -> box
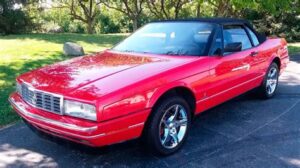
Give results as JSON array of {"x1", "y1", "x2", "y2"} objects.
[{"x1": 258, "y1": 62, "x2": 279, "y2": 99}]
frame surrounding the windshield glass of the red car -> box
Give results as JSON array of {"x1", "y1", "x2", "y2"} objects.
[{"x1": 110, "y1": 20, "x2": 220, "y2": 57}]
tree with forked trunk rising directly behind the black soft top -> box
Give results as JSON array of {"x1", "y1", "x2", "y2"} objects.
[{"x1": 147, "y1": 0, "x2": 190, "y2": 19}]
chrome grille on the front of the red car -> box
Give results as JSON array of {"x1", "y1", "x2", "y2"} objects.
[{"x1": 21, "y1": 84, "x2": 63, "y2": 114}]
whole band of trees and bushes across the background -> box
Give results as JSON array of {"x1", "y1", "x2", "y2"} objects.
[{"x1": 0, "y1": 0, "x2": 300, "y2": 41}]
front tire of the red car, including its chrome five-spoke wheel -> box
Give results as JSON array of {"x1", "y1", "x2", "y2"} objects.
[{"x1": 144, "y1": 96, "x2": 191, "y2": 155}]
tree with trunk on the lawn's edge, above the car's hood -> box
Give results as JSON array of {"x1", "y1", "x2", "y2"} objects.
[{"x1": 57, "y1": 0, "x2": 100, "y2": 34}]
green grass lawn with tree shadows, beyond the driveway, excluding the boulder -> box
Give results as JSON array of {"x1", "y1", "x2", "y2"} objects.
[{"x1": 0, "y1": 34, "x2": 300, "y2": 127}]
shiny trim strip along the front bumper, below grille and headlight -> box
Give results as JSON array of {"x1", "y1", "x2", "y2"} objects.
[{"x1": 9, "y1": 98, "x2": 97, "y2": 132}]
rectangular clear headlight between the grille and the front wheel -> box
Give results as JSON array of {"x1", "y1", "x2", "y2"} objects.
[{"x1": 64, "y1": 100, "x2": 97, "y2": 121}]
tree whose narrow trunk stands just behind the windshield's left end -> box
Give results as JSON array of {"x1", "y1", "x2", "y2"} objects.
[{"x1": 102, "y1": 0, "x2": 145, "y2": 31}]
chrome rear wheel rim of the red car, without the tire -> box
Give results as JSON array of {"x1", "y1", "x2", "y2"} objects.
[{"x1": 266, "y1": 67, "x2": 278, "y2": 95}]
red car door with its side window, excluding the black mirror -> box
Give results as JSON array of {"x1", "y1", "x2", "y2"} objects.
[{"x1": 207, "y1": 25, "x2": 255, "y2": 106}]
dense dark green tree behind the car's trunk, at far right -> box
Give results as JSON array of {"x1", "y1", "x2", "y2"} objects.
[{"x1": 244, "y1": 0, "x2": 300, "y2": 41}]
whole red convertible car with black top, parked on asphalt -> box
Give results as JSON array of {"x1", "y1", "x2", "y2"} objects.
[{"x1": 9, "y1": 19, "x2": 289, "y2": 155}]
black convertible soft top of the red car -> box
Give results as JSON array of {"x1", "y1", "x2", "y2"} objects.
[{"x1": 154, "y1": 18, "x2": 266, "y2": 43}]
